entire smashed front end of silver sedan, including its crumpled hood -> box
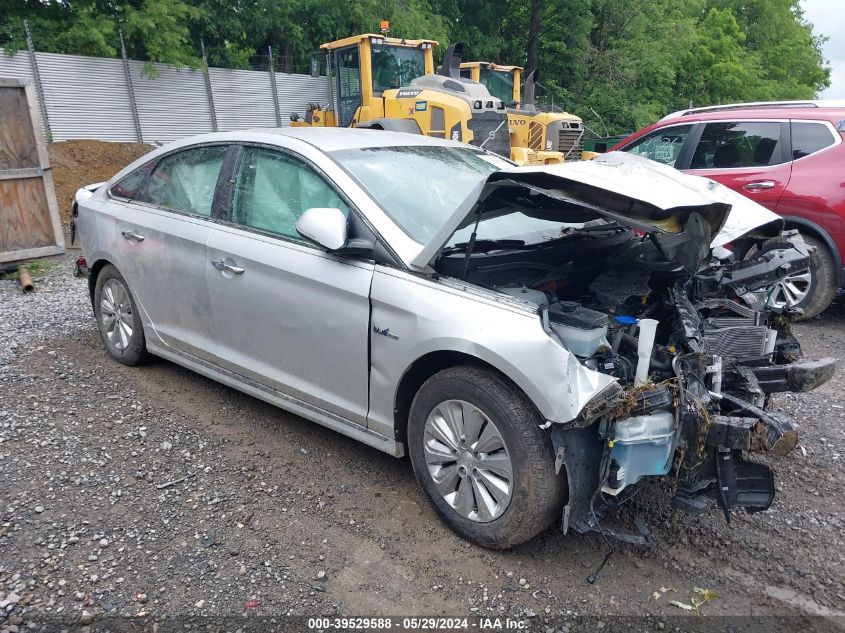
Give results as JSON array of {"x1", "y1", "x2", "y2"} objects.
[{"x1": 417, "y1": 155, "x2": 835, "y2": 543}]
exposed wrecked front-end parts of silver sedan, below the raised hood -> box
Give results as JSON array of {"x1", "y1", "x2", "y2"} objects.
[{"x1": 551, "y1": 226, "x2": 835, "y2": 542}]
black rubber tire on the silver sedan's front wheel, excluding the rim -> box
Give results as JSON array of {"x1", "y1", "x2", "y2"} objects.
[{"x1": 408, "y1": 366, "x2": 565, "y2": 549}]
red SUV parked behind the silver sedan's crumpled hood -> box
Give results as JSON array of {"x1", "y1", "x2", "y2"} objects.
[{"x1": 613, "y1": 101, "x2": 845, "y2": 318}]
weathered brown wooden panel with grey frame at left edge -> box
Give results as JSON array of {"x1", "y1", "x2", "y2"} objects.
[{"x1": 0, "y1": 78, "x2": 65, "y2": 265}]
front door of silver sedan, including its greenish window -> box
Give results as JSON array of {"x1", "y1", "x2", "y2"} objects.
[{"x1": 206, "y1": 147, "x2": 373, "y2": 426}]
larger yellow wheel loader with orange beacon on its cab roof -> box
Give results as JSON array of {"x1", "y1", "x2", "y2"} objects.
[{"x1": 291, "y1": 33, "x2": 511, "y2": 158}]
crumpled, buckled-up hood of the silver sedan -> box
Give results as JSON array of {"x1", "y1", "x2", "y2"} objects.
[{"x1": 411, "y1": 152, "x2": 783, "y2": 271}]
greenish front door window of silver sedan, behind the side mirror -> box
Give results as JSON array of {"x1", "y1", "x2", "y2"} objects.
[{"x1": 232, "y1": 147, "x2": 349, "y2": 240}]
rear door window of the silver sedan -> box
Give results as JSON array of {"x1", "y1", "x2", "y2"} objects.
[{"x1": 143, "y1": 145, "x2": 228, "y2": 217}]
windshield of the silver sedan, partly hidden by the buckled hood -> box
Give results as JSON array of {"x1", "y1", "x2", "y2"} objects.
[{"x1": 332, "y1": 146, "x2": 588, "y2": 244}]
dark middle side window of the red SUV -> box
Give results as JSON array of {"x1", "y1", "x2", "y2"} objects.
[{"x1": 690, "y1": 121, "x2": 784, "y2": 169}]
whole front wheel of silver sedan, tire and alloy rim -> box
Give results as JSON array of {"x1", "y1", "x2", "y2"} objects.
[{"x1": 408, "y1": 366, "x2": 565, "y2": 549}]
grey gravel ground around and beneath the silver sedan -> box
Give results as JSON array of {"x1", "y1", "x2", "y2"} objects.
[{"x1": 0, "y1": 256, "x2": 845, "y2": 633}]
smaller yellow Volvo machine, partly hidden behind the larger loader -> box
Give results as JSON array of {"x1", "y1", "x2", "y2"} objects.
[{"x1": 460, "y1": 62, "x2": 584, "y2": 164}]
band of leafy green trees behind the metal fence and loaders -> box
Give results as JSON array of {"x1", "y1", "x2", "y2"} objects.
[{"x1": 0, "y1": 0, "x2": 830, "y2": 133}]
